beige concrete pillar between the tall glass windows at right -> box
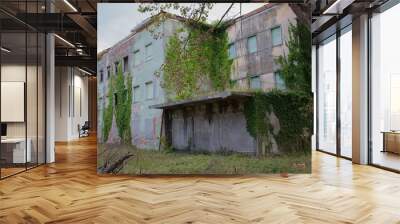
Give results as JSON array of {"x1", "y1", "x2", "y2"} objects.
[{"x1": 352, "y1": 14, "x2": 368, "y2": 164}]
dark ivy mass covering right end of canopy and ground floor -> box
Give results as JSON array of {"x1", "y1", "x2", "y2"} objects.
[{"x1": 244, "y1": 90, "x2": 313, "y2": 152}]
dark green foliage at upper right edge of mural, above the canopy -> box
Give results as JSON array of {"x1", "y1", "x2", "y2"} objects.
[{"x1": 276, "y1": 23, "x2": 311, "y2": 95}]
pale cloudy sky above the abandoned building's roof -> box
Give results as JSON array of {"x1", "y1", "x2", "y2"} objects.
[{"x1": 97, "y1": 3, "x2": 267, "y2": 52}]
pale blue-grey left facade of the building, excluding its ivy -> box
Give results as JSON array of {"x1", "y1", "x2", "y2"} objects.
[{"x1": 97, "y1": 18, "x2": 181, "y2": 149}]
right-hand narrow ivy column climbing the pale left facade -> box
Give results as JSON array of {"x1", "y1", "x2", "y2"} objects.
[{"x1": 114, "y1": 63, "x2": 132, "y2": 143}]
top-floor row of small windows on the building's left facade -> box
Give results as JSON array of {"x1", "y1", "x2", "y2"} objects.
[{"x1": 100, "y1": 43, "x2": 153, "y2": 82}]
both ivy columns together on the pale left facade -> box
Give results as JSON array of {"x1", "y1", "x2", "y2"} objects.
[{"x1": 103, "y1": 60, "x2": 132, "y2": 143}]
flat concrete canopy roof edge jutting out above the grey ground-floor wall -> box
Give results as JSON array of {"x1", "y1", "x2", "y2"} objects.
[{"x1": 149, "y1": 91, "x2": 253, "y2": 109}]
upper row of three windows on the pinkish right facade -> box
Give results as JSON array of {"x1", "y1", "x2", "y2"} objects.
[{"x1": 229, "y1": 26, "x2": 282, "y2": 58}]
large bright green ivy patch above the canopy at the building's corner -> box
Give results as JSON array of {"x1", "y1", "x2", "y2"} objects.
[{"x1": 163, "y1": 23, "x2": 232, "y2": 100}]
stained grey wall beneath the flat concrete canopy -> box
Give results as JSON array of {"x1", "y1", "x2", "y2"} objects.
[{"x1": 168, "y1": 103, "x2": 256, "y2": 154}]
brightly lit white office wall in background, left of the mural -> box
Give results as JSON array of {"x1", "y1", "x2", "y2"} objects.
[{"x1": 55, "y1": 67, "x2": 88, "y2": 141}]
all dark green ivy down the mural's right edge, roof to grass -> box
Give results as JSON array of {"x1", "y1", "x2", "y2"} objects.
[{"x1": 245, "y1": 23, "x2": 313, "y2": 155}]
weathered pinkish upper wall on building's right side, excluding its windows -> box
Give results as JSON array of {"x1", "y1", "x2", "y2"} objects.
[{"x1": 227, "y1": 3, "x2": 296, "y2": 90}]
